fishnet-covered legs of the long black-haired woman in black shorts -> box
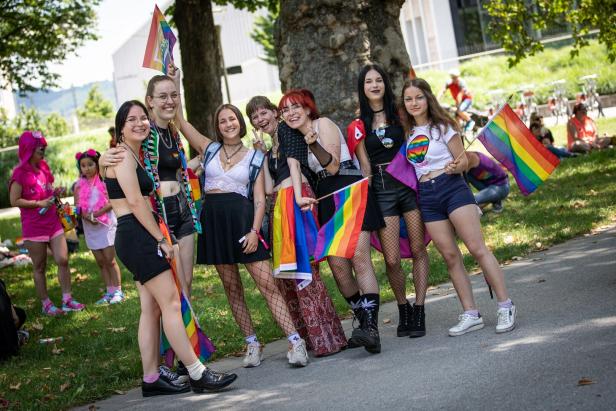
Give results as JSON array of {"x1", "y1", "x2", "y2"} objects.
[{"x1": 379, "y1": 210, "x2": 430, "y2": 305}]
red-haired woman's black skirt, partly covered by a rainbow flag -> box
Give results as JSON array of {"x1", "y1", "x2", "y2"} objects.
[{"x1": 316, "y1": 175, "x2": 385, "y2": 231}]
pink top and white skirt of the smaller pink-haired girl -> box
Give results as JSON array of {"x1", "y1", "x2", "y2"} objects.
[{"x1": 75, "y1": 175, "x2": 118, "y2": 250}]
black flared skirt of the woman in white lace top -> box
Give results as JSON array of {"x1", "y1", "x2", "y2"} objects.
[{"x1": 197, "y1": 193, "x2": 270, "y2": 264}]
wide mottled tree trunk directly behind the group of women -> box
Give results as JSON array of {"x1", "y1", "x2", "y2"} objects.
[{"x1": 275, "y1": 0, "x2": 410, "y2": 127}]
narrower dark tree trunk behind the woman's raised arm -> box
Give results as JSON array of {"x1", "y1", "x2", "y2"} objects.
[{"x1": 173, "y1": 0, "x2": 222, "y2": 152}]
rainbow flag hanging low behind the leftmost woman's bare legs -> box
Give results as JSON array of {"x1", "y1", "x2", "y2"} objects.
[{"x1": 158, "y1": 218, "x2": 216, "y2": 365}]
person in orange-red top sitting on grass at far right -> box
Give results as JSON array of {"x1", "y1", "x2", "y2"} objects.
[{"x1": 567, "y1": 103, "x2": 612, "y2": 153}]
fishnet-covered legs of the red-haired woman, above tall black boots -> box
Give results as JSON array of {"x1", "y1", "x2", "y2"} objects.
[{"x1": 327, "y1": 231, "x2": 379, "y2": 298}]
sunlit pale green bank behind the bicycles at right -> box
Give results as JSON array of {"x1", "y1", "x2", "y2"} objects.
[{"x1": 418, "y1": 40, "x2": 616, "y2": 108}]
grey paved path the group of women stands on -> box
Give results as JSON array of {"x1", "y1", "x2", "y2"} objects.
[{"x1": 78, "y1": 227, "x2": 616, "y2": 410}]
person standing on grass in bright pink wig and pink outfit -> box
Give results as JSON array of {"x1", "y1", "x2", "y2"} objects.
[{"x1": 9, "y1": 130, "x2": 85, "y2": 317}]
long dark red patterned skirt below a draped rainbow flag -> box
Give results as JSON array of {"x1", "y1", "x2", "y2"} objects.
[{"x1": 269, "y1": 183, "x2": 347, "y2": 357}]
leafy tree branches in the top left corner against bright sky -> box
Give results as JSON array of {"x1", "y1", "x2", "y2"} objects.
[{"x1": 0, "y1": 0, "x2": 100, "y2": 92}]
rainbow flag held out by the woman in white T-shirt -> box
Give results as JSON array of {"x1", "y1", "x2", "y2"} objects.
[{"x1": 478, "y1": 104, "x2": 560, "y2": 196}]
